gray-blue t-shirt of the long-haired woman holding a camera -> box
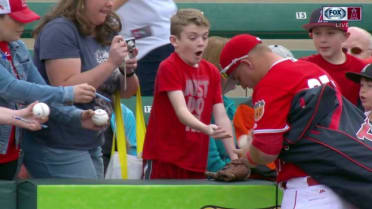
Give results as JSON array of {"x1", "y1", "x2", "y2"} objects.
[{"x1": 34, "y1": 17, "x2": 120, "y2": 150}]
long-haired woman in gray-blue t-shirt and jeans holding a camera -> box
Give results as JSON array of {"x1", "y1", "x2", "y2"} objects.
[{"x1": 25, "y1": 0, "x2": 138, "y2": 179}]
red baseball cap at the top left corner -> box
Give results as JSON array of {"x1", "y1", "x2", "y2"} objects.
[{"x1": 0, "y1": 0, "x2": 40, "y2": 23}]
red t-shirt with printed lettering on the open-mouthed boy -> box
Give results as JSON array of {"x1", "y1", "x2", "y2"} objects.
[{"x1": 143, "y1": 53, "x2": 222, "y2": 172}]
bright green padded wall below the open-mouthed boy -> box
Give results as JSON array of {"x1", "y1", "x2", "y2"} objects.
[{"x1": 18, "y1": 179, "x2": 281, "y2": 209}]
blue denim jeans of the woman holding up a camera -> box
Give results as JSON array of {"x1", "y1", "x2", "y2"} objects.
[{"x1": 22, "y1": 138, "x2": 104, "y2": 179}]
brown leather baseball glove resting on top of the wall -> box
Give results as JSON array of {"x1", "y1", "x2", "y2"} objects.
[{"x1": 205, "y1": 158, "x2": 251, "y2": 182}]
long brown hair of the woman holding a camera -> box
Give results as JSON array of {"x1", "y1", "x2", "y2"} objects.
[{"x1": 33, "y1": 0, "x2": 121, "y2": 45}]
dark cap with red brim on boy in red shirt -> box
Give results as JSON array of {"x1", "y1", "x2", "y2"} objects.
[{"x1": 302, "y1": 8, "x2": 349, "y2": 32}]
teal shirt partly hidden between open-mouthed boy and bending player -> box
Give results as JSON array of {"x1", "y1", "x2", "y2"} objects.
[{"x1": 207, "y1": 96, "x2": 236, "y2": 172}]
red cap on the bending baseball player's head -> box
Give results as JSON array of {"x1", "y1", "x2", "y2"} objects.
[{"x1": 220, "y1": 34, "x2": 262, "y2": 75}]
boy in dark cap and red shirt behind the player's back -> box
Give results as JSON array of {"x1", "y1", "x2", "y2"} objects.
[{"x1": 302, "y1": 8, "x2": 365, "y2": 105}]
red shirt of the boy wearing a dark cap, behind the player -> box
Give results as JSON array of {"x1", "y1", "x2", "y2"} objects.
[{"x1": 302, "y1": 54, "x2": 366, "y2": 105}]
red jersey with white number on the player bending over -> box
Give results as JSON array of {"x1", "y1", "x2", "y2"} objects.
[{"x1": 252, "y1": 59, "x2": 333, "y2": 182}]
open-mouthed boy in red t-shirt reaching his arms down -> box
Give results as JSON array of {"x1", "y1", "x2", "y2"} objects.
[{"x1": 143, "y1": 9, "x2": 237, "y2": 179}]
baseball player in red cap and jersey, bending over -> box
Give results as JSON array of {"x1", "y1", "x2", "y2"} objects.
[{"x1": 220, "y1": 34, "x2": 356, "y2": 209}]
